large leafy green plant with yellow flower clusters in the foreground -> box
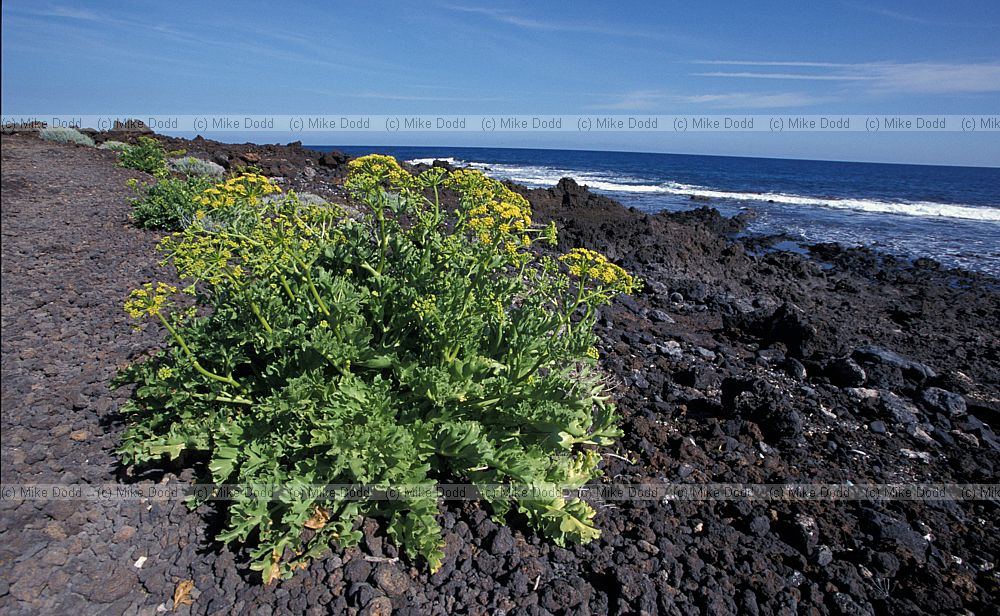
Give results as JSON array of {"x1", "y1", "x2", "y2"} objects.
[{"x1": 118, "y1": 156, "x2": 637, "y2": 582}]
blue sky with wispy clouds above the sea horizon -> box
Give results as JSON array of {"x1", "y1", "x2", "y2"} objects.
[{"x1": 2, "y1": 0, "x2": 1000, "y2": 166}]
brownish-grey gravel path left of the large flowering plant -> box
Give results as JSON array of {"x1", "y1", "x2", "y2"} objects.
[{"x1": 0, "y1": 137, "x2": 189, "y2": 614}]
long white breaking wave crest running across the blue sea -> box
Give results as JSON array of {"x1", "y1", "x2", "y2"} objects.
[{"x1": 409, "y1": 158, "x2": 1000, "y2": 222}]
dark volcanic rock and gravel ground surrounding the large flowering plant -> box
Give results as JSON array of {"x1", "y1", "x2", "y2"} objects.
[{"x1": 0, "y1": 133, "x2": 1000, "y2": 614}]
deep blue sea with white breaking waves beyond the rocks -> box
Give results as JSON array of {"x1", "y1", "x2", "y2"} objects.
[{"x1": 310, "y1": 146, "x2": 1000, "y2": 276}]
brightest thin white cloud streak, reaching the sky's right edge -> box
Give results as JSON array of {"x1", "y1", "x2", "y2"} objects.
[{"x1": 694, "y1": 60, "x2": 1000, "y2": 94}]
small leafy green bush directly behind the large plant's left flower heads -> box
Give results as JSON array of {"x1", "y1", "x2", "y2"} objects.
[{"x1": 129, "y1": 175, "x2": 216, "y2": 231}]
